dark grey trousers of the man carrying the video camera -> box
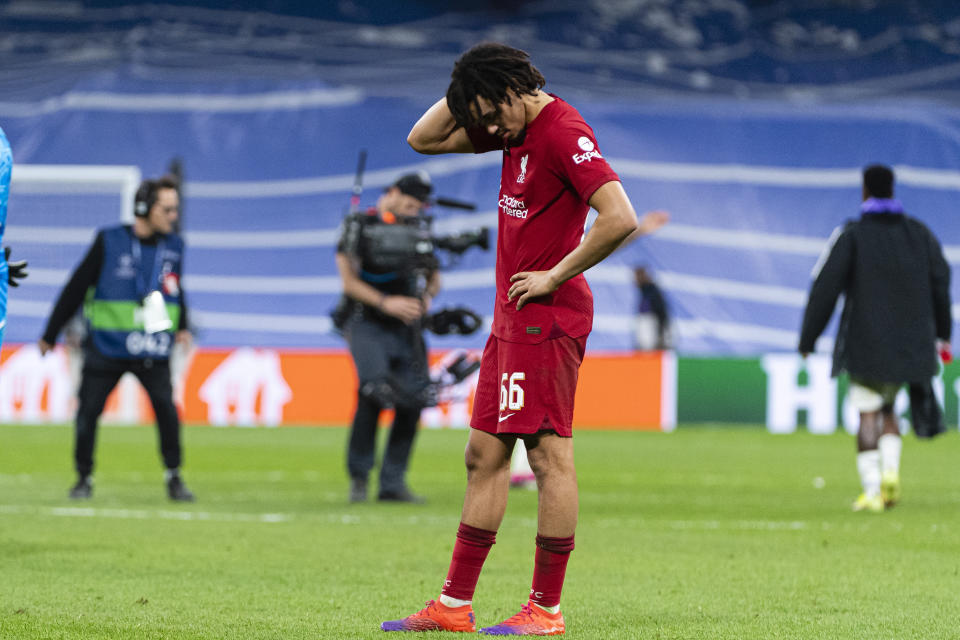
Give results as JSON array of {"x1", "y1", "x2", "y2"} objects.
[{"x1": 345, "y1": 318, "x2": 429, "y2": 492}]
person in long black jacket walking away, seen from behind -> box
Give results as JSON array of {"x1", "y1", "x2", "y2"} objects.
[{"x1": 799, "y1": 165, "x2": 952, "y2": 512}]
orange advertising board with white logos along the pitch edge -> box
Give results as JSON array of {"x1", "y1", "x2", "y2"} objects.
[{"x1": 0, "y1": 344, "x2": 674, "y2": 429}]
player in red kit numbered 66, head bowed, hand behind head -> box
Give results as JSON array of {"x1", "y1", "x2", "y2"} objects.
[{"x1": 381, "y1": 43, "x2": 667, "y2": 635}]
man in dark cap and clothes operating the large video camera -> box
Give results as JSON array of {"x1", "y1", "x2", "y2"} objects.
[{"x1": 335, "y1": 171, "x2": 440, "y2": 502}]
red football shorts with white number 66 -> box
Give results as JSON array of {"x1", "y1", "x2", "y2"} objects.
[{"x1": 470, "y1": 334, "x2": 587, "y2": 437}]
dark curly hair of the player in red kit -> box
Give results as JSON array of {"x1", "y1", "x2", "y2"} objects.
[{"x1": 447, "y1": 42, "x2": 546, "y2": 128}]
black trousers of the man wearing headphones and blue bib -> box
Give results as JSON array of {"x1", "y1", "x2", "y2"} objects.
[{"x1": 73, "y1": 348, "x2": 181, "y2": 476}]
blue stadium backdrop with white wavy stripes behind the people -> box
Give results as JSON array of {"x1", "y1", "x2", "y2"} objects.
[{"x1": 0, "y1": 0, "x2": 960, "y2": 355}]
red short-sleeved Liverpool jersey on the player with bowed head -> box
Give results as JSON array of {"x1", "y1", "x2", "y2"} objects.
[{"x1": 468, "y1": 94, "x2": 620, "y2": 343}]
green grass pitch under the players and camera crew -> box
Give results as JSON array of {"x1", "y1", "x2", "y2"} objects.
[{"x1": 0, "y1": 426, "x2": 960, "y2": 640}]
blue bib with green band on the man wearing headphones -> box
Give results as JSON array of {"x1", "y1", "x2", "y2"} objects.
[{"x1": 84, "y1": 226, "x2": 183, "y2": 358}]
